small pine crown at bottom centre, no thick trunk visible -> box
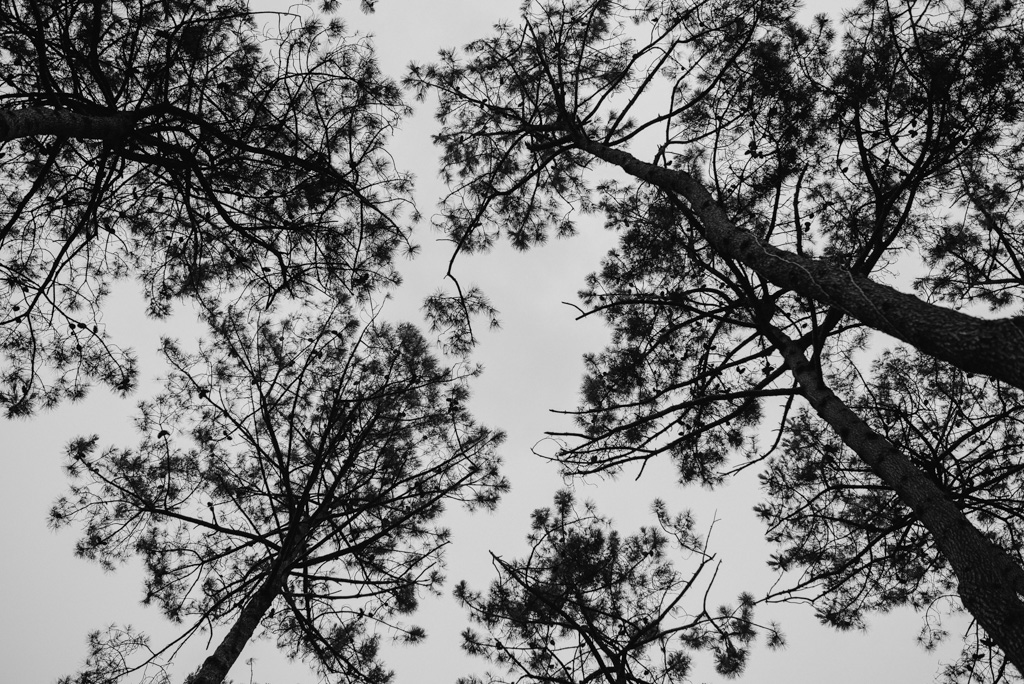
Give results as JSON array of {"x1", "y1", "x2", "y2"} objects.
[{"x1": 456, "y1": 490, "x2": 783, "y2": 684}]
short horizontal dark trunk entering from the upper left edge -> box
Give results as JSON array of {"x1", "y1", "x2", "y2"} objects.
[{"x1": 0, "y1": 106, "x2": 133, "y2": 141}]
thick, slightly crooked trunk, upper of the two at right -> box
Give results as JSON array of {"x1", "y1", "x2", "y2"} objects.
[{"x1": 573, "y1": 135, "x2": 1024, "y2": 389}]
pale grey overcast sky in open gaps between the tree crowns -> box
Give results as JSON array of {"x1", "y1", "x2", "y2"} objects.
[{"x1": 0, "y1": 0, "x2": 970, "y2": 684}]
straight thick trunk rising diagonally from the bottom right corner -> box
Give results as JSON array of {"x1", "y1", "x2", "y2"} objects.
[{"x1": 771, "y1": 330, "x2": 1024, "y2": 673}]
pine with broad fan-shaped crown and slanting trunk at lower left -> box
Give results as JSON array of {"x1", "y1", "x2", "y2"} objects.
[{"x1": 50, "y1": 308, "x2": 507, "y2": 684}]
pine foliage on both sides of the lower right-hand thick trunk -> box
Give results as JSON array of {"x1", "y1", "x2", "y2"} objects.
[{"x1": 757, "y1": 348, "x2": 1024, "y2": 681}]
